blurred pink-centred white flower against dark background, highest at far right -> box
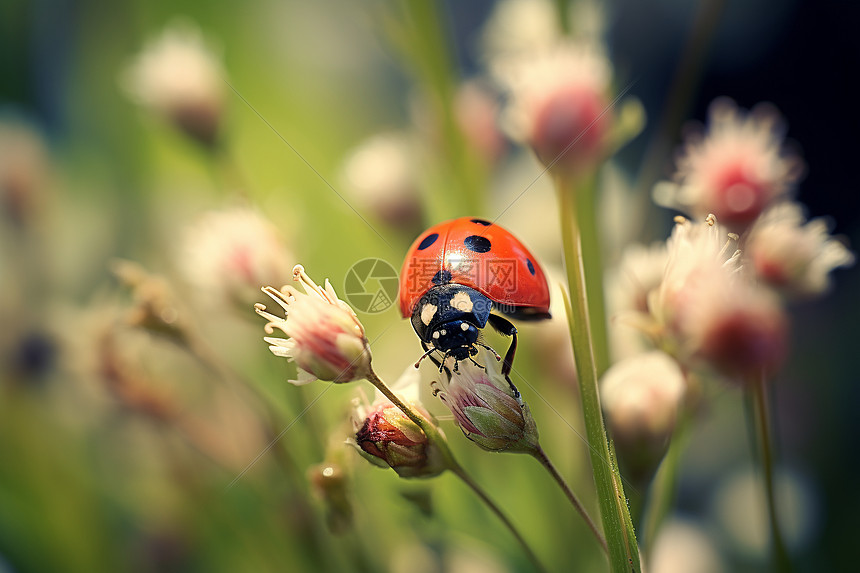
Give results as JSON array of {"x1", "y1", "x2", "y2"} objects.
[{"x1": 654, "y1": 98, "x2": 803, "y2": 233}]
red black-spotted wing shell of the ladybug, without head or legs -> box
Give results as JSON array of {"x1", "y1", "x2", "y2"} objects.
[{"x1": 400, "y1": 217, "x2": 549, "y2": 318}]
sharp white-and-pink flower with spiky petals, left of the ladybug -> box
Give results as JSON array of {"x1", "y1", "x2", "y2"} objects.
[{"x1": 250, "y1": 265, "x2": 371, "y2": 384}]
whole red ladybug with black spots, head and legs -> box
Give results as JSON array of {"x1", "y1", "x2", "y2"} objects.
[{"x1": 399, "y1": 217, "x2": 550, "y2": 376}]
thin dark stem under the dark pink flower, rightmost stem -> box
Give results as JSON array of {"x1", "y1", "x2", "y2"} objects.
[{"x1": 750, "y1": 374, "x2": 792, "y2": 572}]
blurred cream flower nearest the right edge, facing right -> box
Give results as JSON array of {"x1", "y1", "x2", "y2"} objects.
[{"x1": 744, "y1": 202, "x2": 854, "y2": 297}]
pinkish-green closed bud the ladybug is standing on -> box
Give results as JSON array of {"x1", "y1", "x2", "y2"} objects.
[{"x1": 437, "y1": 348, "x2": 538, "y2": 453}]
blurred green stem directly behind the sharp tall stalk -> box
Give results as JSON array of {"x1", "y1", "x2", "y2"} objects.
[{"x1": 571, "y1": 173, "x2": 609, "y2": 377}]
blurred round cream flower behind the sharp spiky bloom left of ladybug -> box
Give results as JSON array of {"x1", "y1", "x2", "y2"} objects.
[{"x1": 178, "y1": 207, "x2": 292, "y2": 306}]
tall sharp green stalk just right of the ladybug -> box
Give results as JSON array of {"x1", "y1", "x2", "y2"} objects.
[{"x1": 556, "y1": 176, "x2": 640, "y2": 573}]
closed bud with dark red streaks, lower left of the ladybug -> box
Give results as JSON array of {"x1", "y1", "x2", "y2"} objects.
[{"x1": 355, "y1": 400, "x2": 445, "y2": 478}]
